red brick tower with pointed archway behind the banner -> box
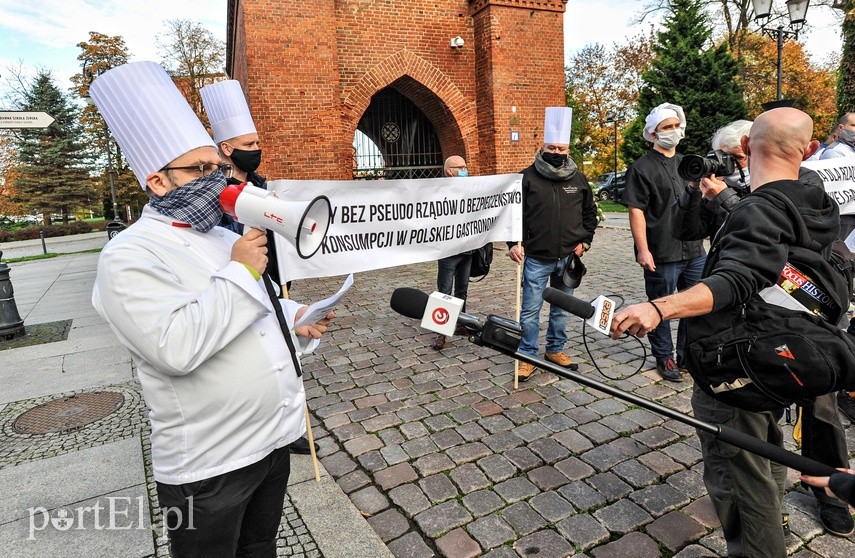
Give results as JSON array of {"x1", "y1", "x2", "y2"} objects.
[{"x1": 227, "y1": 0, "x2": 567, "y2": 179}]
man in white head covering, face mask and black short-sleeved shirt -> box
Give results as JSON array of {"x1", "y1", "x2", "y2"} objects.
[{"x1": 621, "y1": 103, "x2": 706, "y2": 381}]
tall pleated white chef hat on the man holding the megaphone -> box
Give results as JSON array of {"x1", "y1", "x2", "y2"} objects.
[{"x1": 89, "y1": 62, "x2": 216, "y2": 188}]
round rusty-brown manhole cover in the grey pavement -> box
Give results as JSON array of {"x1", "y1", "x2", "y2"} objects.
[{"x1": 13, "y1": 391, "x2": 125, "y2": 434}]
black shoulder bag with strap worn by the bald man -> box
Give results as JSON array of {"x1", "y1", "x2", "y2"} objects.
[{"x1": 685, "y1": 189, "x2": 855, "y2": 412}]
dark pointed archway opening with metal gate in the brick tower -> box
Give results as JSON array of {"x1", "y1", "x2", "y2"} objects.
[{"x1": 353, "y1": 87, "x2": 443, "y2": 180}]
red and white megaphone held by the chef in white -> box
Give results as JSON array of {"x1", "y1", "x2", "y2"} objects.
[{"x1": 220, "y1": 183, "x2": 332, "y2": 259}]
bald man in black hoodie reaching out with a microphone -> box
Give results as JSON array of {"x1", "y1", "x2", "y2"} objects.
[{"x1": 612, "y1": 108, "x2": 839, "y2": 558}]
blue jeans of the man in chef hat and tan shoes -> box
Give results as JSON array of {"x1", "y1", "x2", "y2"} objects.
[{"x1": 519, "y1": 256, "x2": 573, "y2": 356}]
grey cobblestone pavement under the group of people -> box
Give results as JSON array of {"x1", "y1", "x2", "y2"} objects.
[{"x1": 292, "y1": 228, "x2": 855, "y2": 558}]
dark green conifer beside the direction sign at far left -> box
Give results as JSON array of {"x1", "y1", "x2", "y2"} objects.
[{"x1": 14, "y1": 70, "x2": 96, "y2": 225}]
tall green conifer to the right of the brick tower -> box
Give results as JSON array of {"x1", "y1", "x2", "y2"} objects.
[{"x1": 622, "y1": 0, "x2": 746, "y2": 162}]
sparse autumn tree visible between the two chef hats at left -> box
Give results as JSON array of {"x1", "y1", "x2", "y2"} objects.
[{"x1": 157, "y1": 19, "x2": 226, "y2": 126}]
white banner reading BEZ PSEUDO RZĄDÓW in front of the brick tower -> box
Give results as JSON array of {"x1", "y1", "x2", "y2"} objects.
[{"x1": 267, "y1": 174, "x2": 522, "y2": 281}]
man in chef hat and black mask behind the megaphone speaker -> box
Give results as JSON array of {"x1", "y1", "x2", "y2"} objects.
[{"x1": 201, "y1": 79, "x2": 319, "y2": 462}]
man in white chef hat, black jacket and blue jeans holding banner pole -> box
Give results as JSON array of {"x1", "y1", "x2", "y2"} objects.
[{"x1": 508, "y1": 107, "x2": 597, "y2": 382}]
